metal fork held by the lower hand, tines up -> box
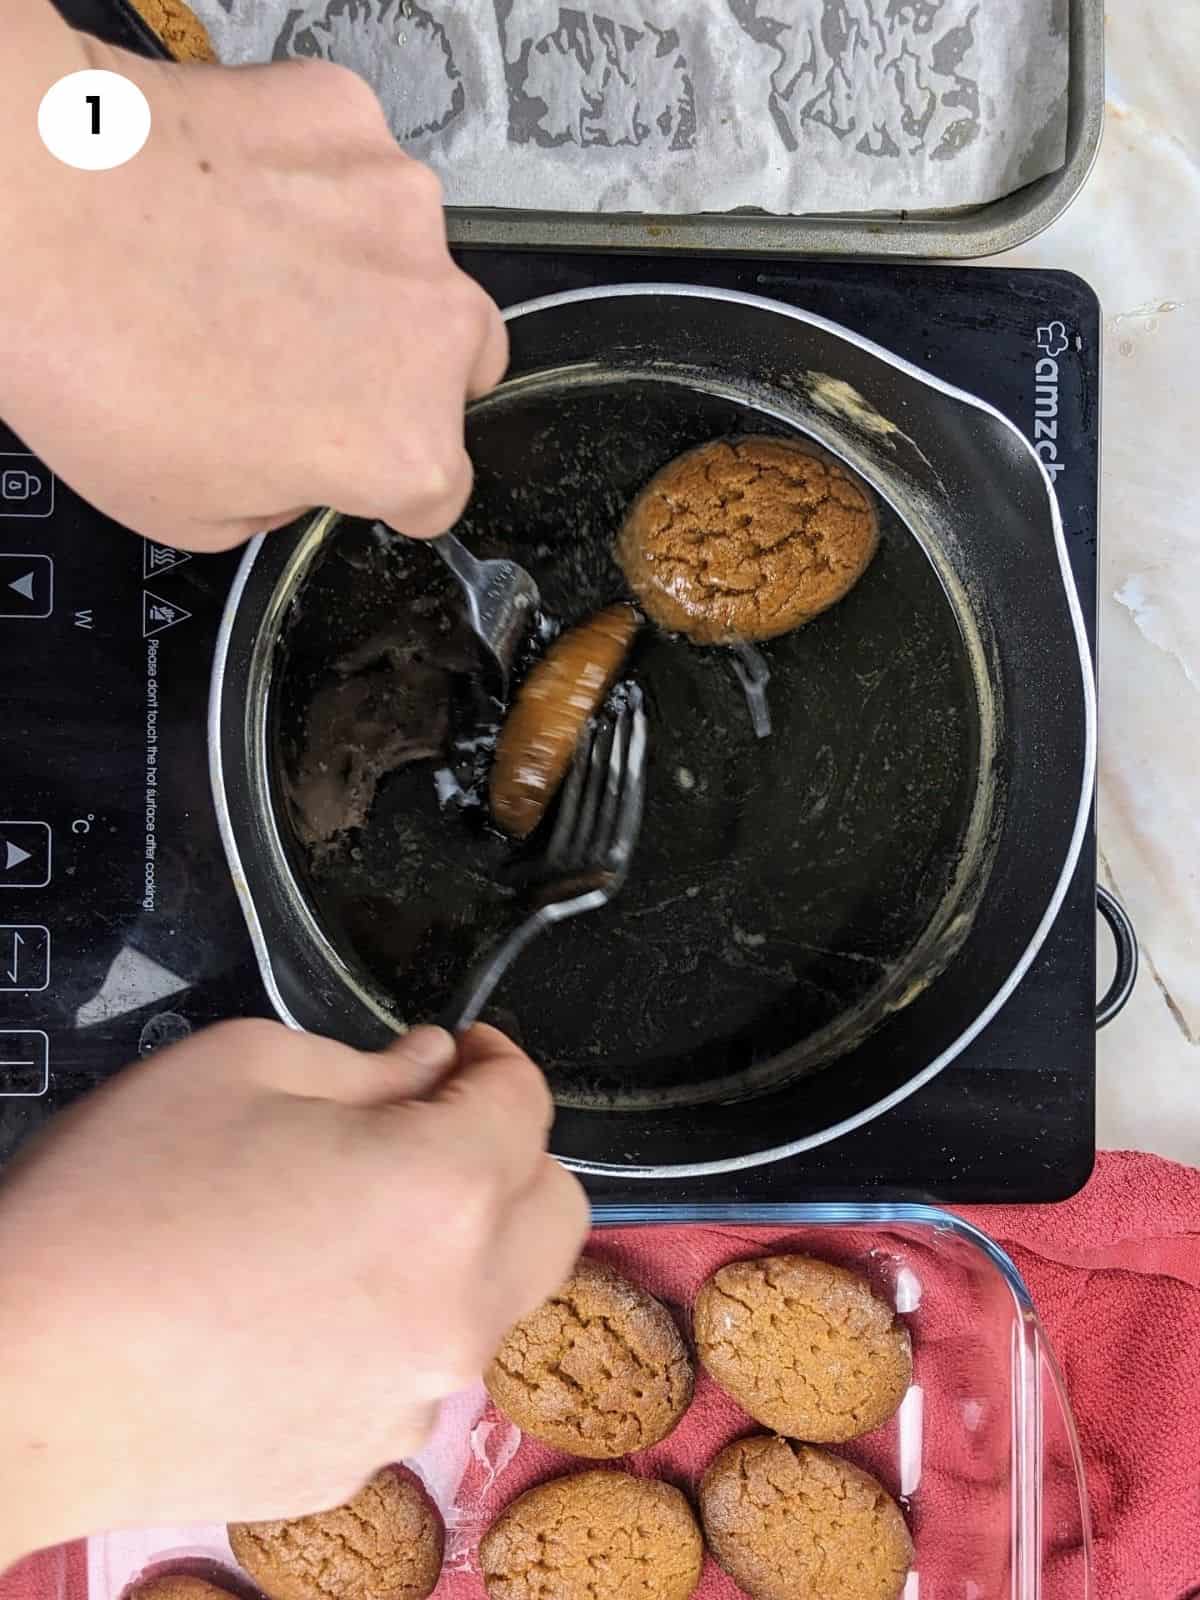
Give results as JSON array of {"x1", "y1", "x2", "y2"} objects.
[{"x1": 440, "y1": 683, "x2": 646, "y2": 1034}]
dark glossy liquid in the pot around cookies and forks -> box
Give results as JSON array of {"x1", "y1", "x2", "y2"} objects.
[{"x1": 277, "y1": 378, "x2": 990, "y2": 1107}]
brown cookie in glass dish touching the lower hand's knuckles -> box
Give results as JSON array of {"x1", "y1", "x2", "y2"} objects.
[{"x1": 485, "y1": 1256, "x2": 693, "y2": 1461}]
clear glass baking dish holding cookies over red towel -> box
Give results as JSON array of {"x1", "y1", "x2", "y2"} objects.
[{"x1": 72, "y1": 1205, "x2": 1094, "y2": 1600}]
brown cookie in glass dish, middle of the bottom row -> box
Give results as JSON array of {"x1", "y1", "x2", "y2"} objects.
[{"x1": 478, "y1": 1472, "x2": 704, "y2": 1600}]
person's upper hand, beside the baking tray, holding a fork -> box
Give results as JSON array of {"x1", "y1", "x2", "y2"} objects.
[{"x1": 0, "y1": 6, "x2": 507, "y2": 550}]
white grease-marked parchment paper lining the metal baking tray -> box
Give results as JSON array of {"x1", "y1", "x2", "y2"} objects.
[{"x1": 183, "y1": 0, "x2": 1067, "y2": 213}]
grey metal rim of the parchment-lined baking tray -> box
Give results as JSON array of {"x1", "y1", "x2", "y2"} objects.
[{"x1": 446, "y1": 0, "x2": 1104, "y2": 259}]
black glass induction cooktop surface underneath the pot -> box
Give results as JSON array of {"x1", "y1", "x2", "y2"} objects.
[{"x1": 0, "y1": 251, "x2": 1099, "y2": 1202}]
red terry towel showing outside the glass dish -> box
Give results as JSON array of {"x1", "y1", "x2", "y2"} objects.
[{"x1": 963, "y1": 1150, "x2": 1200, "y2": 1600}]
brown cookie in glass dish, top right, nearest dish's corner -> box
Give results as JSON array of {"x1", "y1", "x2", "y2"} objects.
[{"x1": 694, "y1": 1256, "x2": 912, "y2": 1445}]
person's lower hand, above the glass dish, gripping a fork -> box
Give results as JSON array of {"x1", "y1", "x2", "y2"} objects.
[{"x1": 0, "y1": 1022, "x2": 587, "y2": 1570}]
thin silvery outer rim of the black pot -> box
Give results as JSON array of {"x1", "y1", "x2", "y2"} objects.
[{"x1": 208, "y1": 282, "x2": 1096, "y2": 1181}]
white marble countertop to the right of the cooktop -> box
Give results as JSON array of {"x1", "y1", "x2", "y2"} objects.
[{"x1": 1000, "y1": 0, "x2": 1200, "y2": 1165}]
